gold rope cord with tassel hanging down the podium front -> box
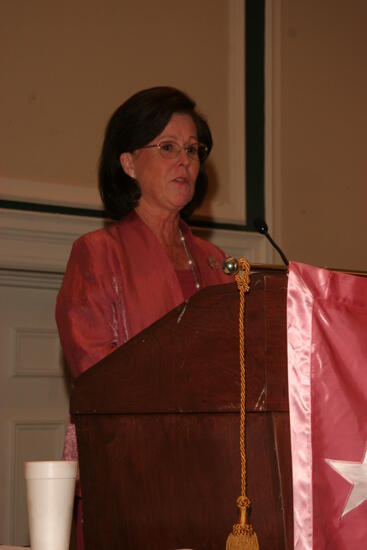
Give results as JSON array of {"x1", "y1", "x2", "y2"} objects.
[{"x1": 224, "y1": 258, "x2": 259, "y2": 550}]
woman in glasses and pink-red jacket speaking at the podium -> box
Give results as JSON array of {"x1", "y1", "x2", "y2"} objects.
[{"x1": 56, "y1": 87, "x2": 232, "y2": 548}]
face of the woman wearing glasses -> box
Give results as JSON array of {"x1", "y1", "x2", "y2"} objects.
[{"x1": 120, "y1": 113, "x2": 200, "y2": 215}]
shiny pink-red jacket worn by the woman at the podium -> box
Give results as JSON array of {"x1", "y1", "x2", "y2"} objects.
[{"x1": 56, "y1": 212, "x2": 233, "y2": 377}]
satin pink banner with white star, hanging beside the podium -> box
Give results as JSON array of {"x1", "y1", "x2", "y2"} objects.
[{"x1": 287, "y1": 262, "x2": 367, "y2": 550}]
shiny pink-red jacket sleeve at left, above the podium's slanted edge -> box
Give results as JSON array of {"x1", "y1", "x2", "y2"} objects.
[{"x1": 56, "y1": 237, "x2": 122, "y2": 377}]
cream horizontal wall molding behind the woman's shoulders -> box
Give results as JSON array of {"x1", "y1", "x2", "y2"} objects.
[{"x1": 0, "y1": 205, "x2": 272, "y2": 272}]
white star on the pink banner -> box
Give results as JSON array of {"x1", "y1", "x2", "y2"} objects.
[{"x1": 325, "y1": 449, "x2": 367, "y2": 517}]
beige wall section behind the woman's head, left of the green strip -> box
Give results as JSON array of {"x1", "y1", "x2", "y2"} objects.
[{"x1": 0, "y1": 0, "x2": 229, "y2": 207}]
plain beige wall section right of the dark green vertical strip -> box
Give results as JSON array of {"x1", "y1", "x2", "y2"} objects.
[{"x1": 274, "y1": 0, "x2": 367, "y2": 270}]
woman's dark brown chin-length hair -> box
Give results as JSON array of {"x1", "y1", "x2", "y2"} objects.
[{"x1": 98, "y1": 86, "x2": 213, "y2": 220}]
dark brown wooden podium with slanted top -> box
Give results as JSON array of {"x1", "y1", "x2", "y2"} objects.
[{"x1": 71, "y1": 268, "x2": 293, "y2": 550}]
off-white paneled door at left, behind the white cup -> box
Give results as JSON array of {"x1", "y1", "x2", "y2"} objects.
[{"x1": 0, "y1": 280, "x2": 69, "y2": 545}]
